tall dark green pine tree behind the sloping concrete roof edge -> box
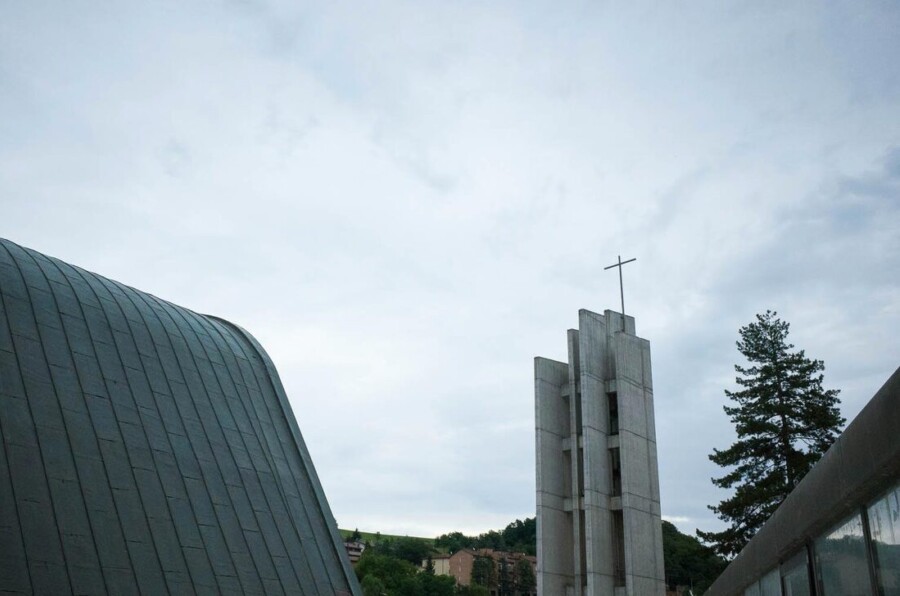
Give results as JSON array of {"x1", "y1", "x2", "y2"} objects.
[{"x1": 697, "y1": 311, "x2": 844, "y2": 556}]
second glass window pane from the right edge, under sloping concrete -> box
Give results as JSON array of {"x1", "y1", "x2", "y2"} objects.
[{"x1": 815, "y1": 514, "x2": 872, "y2": 596}]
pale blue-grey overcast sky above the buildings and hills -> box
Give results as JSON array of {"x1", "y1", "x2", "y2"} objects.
[{"x1": 0, "y1": 0, "x2": 900, "y2": 536}]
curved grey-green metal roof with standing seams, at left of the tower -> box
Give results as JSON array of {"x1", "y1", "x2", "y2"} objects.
[{"x1": 0, "y1": 240, "x2": 359, "y2": 596}]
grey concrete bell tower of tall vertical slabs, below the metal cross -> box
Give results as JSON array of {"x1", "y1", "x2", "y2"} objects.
[{"x1": 535, "y1": 310, "x2": 665, "y2": 596}]
